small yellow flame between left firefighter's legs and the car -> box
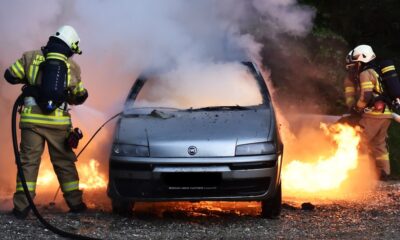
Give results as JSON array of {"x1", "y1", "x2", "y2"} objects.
[{"x1": 79, "y1": 159, "x2": 107, "y2": 189}]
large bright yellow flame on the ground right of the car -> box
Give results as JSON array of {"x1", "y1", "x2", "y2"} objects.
[{"x1": 282, "y1": 123, "x2": 360, "y2": 196}]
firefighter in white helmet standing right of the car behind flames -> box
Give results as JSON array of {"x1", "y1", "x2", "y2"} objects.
[{"x1": 344, "y1": 45, "x2": 392, "y2": 180}]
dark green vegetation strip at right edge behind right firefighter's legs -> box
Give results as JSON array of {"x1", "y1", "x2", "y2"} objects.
[{"x1": 388, "y1": 122, "x2": 400, "y2": 176}]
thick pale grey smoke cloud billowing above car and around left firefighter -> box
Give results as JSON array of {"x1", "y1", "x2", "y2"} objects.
[{"x1": 0, "y1": 0, "x2": 314, "y2": 202}]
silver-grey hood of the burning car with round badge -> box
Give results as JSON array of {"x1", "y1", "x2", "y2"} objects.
[{"x1": 117, "y1": 107, "x2": 275, "y2": 157}]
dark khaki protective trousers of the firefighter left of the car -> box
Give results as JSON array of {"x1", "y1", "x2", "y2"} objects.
[{"x1": 14, "y1": 126, "x2": 82, "y2": 211}]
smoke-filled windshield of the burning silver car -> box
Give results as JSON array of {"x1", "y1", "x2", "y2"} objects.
[{"x1": 127, "y1": 63, "x2": 264, "y2": 110}]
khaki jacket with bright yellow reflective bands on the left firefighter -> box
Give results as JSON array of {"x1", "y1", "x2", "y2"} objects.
[{"x1": 6, "y1": 50, "x2": 88, "y2": 129}]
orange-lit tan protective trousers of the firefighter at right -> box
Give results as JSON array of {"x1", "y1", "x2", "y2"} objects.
[{"x1": 360, "y1": 117, "x2": 391, "y2": 175}]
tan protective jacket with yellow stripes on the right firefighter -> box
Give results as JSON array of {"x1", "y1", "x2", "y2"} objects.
[{"x1": 344, "y1": 68, "x2": 392, "y2": 119}]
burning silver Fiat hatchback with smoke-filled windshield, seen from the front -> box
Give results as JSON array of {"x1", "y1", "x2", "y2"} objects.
[{"x1": 108, "y1": 62, "x2": 283, "y2": 218}]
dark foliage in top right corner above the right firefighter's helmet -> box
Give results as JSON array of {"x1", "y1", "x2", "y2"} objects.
[{"x1": 300, "y1": 0, "x2": 400, "y2": 65}]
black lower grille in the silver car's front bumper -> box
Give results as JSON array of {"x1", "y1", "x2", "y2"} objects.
[{"x1": 115, "y1": 176, "x2": 271, "y2": 199}]
